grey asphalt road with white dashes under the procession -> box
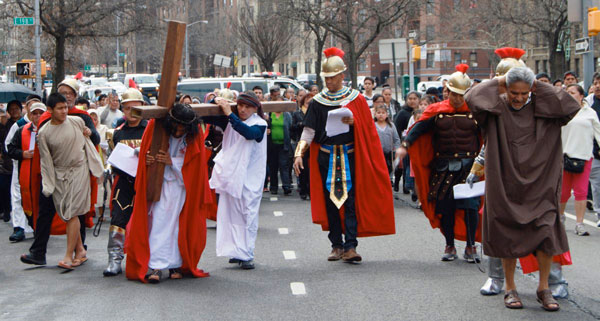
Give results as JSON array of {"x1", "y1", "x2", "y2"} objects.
[{"x1": 0, "y1": 190, "x2": 600, "y2": 320}]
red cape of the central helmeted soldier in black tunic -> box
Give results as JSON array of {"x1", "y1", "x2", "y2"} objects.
[{"x1": 310, "y1": 95, "x2": 396, "y2": 237}]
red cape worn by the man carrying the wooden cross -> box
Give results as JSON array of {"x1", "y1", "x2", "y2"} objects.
[{"x1": 125, "y1": 119, "x2": 215, "y2": 282}]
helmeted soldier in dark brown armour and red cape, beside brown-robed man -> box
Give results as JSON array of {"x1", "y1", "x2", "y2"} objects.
[{"x1": 400, "y1": 64, "x2": 481, "y2": 263}]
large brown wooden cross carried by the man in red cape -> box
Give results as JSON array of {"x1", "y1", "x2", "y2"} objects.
[{"x1": 132, "y1": 21, "x2": 297, "y2": 202}]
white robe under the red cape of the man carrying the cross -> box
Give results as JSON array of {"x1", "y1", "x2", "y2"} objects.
[{"x1": 148, "y1": 136, "x2": 186, "y2": 270}]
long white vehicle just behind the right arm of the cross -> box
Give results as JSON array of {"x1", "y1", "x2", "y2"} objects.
[{"x1": 177, "y1": 77, "x2": 302, "y2": 100}]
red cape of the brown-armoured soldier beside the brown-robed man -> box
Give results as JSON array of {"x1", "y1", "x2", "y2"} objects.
[{"x1": 408, "y1": 100, "x2": 483, "y2": 242}]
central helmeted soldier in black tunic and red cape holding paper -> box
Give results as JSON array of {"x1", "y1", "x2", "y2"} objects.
[{"x1": 294, "y1": 47, "x2": 396, "y2": 262}]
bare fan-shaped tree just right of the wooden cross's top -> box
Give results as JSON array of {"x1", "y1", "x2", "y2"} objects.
[{"x1": 232, "y1": 0, "x2": 294, "y2": 71}]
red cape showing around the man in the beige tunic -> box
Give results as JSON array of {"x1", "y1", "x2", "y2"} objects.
[{"x1": 31, "y1": 107, "x2": 98, "y2": 235}]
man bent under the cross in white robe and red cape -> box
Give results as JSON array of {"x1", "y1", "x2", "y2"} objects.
[{"x1": 125, "y1": 103, "x2": 214, "y2": 283}]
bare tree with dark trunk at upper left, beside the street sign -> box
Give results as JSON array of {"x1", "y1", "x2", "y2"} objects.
[{"x1": 13, "y1": 0, "x2": 149, "y2": 90}]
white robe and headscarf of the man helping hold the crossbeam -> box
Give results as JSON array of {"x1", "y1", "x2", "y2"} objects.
[{"x1": 209, "y1": 114, "x2": 267, "y2": 261}]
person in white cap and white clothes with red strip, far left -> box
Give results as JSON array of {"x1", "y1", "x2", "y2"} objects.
[{"x1": 6, "y1": 95, "x2": 46, "y2": 242}]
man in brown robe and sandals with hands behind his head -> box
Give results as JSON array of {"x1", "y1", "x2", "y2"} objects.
[{"x1": 465, "y1": 67, "x2": 580, "y2": 311}]
